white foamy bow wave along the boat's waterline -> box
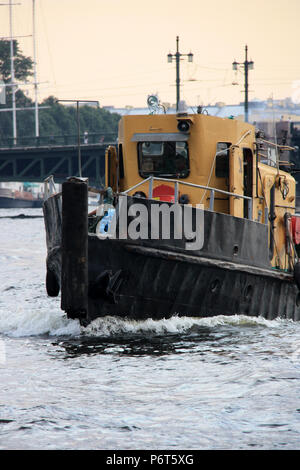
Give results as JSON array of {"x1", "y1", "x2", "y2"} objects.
[{"x1": 0, "y1": 301, "x2": 286, "y2": 337}]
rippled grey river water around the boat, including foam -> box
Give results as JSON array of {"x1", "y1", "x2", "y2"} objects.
[{"x1": 0, "y1": 209, "x2": 300, "y2": 450}]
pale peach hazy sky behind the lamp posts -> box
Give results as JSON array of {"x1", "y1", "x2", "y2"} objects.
[{"x1": 0, "y1": 0, "x2": 300, "y2": 106}]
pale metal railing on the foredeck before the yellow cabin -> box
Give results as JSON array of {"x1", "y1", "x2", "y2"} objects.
[{"x1": 121, "y1": 176, "x2": 253, "y2": 220}]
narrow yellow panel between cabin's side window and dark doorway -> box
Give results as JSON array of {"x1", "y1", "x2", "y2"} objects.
[{"x1": 229, "y1": 147, "x2": 244, "y2": 217}]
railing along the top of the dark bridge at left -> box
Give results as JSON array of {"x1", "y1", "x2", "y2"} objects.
[{"x1": 0, "y1": 132, "x2": 118, "y2": 148}]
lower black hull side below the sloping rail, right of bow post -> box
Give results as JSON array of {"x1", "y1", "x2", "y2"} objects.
[{"x1": 88, "y1": 239, "x2": 300, "y2": 321}]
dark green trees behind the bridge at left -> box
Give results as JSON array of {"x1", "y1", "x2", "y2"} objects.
[{"x1": 0, "y1": 39, "x2": 120, "y2": 145}]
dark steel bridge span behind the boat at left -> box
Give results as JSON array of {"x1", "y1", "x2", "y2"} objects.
[{"x1": 0, "y1": 135, "x2": 116, "y2": 187}]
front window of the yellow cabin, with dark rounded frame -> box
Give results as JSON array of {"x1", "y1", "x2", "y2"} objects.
[{"x1": 138, "y1": 142, "x2": 190, "y2": 178}]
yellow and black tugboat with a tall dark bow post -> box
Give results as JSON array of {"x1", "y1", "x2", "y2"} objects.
[{"x1": 44, "y1": 103, "x2": 300, "y2": 325}]
